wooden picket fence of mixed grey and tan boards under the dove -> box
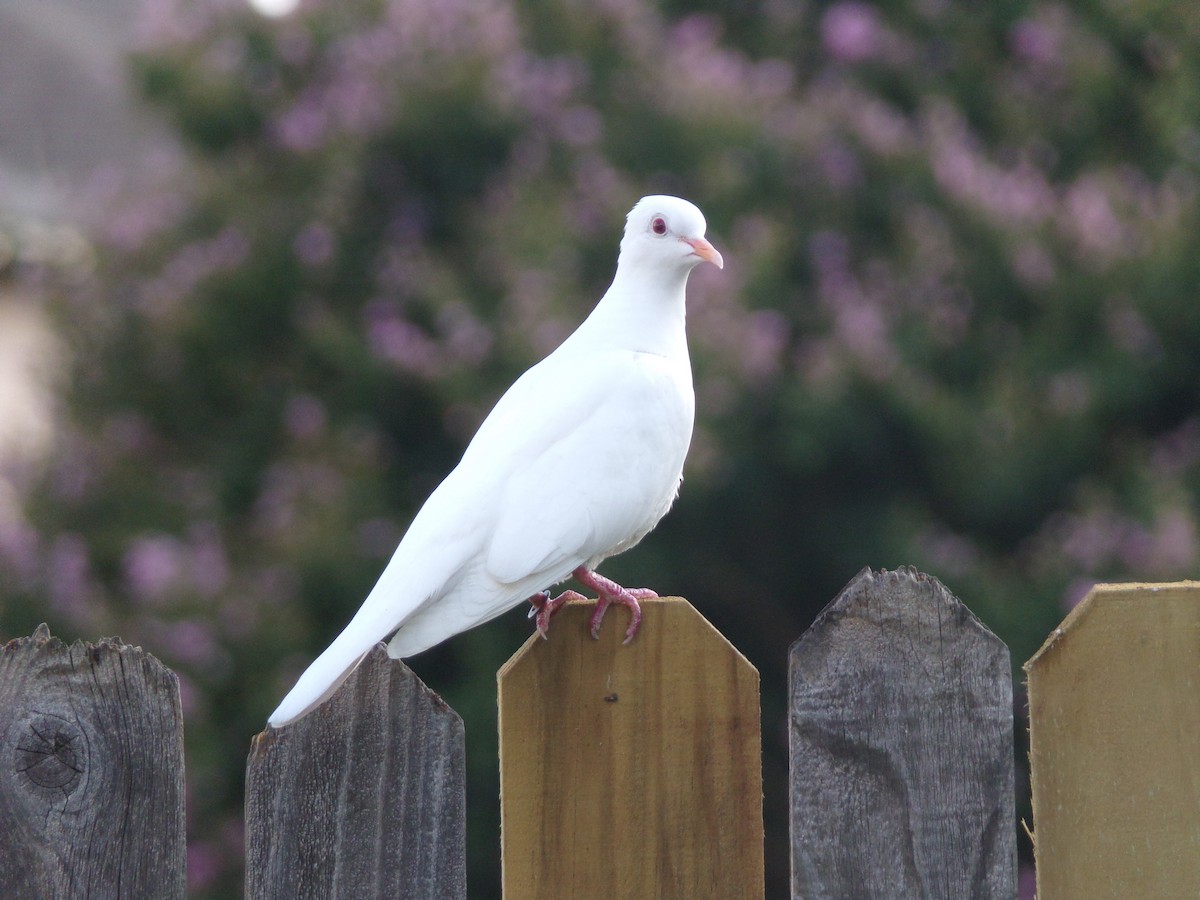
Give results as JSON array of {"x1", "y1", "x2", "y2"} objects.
[{"x1": 0, "y1": 570, "x2": 1200, "y2": 900}]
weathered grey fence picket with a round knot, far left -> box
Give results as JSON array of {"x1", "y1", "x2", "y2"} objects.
[{"x1": 0, "y1": 625, "x2": 187, "y2": 899}]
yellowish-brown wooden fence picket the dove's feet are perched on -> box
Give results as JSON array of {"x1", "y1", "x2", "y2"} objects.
[{"x1": 498, "y1": 598, "x2": 763, "y2": 900}]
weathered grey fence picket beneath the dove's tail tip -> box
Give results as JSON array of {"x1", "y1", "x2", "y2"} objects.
[{"x1": 246, "y1": 644, "x2": 467, "y2": 900}]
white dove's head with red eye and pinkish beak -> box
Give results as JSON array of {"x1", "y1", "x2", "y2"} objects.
[{"x1": 620, "y1": 194, "x2": 725, "y2": 274}]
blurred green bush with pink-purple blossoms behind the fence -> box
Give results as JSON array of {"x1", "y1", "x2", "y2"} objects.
[{"x1": 0, "y1": 0, "x2": 1200, "y2": 898}]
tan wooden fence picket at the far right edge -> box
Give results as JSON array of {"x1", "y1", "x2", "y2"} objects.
[{"x1": 1025, "y1": 581, "x2": 1200, "y2": 900}]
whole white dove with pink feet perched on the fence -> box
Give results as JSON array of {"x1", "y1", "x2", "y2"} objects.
[{"x1": 269, "y1": 196, "x2": 725, "y2": 727}]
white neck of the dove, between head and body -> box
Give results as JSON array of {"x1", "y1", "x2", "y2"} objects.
[{"x1": 578, "y1": 265, "x2": 691, "y2": 359}]
